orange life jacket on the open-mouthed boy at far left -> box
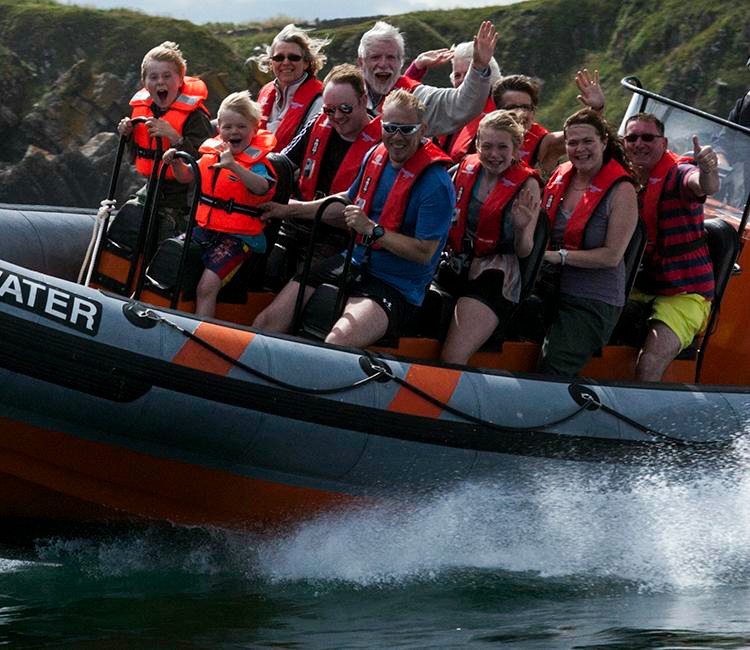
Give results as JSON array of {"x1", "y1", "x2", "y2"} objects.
[{"x1": 130, "y1": 77, "x2": 209, "y2": 179}]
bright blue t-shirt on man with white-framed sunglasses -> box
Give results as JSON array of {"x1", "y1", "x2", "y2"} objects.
[{"x1": 348, "y1": 159, "x2": 456, "y2": 305}]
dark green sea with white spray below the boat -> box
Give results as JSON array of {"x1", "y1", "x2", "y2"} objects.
[{"x1": 0, "y1": 438, "x2": 750, "y2": 650}]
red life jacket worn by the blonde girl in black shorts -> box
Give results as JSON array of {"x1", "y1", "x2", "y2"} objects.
[{"x1": 448, "y1": 154, "x2": 541, "y2": 257}]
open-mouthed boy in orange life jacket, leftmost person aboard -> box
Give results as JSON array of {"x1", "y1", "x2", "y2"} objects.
[{"x1": 117, "y1": 41, "x2": 214, "y2": 241}]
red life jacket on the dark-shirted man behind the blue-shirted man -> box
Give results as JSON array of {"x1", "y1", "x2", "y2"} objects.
[{"x1": 299, "y1": 113, "x2": 382, "y2": 201}]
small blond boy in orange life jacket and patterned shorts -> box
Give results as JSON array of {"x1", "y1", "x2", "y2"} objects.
[{"x1": 163, "y1": 91, "x2": 276, "y2": 316}]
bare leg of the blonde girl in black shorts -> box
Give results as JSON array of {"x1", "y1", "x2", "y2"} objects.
[{"x1": 440, "y1": 298, "x2": 500, "y2": 363}]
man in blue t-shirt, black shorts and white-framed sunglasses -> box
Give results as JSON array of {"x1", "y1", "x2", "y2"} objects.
[{"x1": 253, "y1": 90, "x2": 455, "y2": 347}]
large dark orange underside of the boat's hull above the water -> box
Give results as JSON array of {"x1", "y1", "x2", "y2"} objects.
[{"x1": 0, "y1": 418, "x2": 357, "y2": 528}]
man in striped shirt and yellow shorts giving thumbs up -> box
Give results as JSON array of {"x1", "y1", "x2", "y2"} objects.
[{"x1": 624, "y1": 113, "x2": 719, "y2": 381}]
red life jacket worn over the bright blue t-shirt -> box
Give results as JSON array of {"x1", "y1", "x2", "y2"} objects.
[{"x1": 354, "y1": 140, "x2": 451, "y2": 248}]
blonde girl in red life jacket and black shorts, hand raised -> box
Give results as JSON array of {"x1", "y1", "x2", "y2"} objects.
[{"x1": 438, "y1": 111, "x2": 541, "y2": 364}]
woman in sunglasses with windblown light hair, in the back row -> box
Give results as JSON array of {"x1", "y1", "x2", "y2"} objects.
[{"x1": 248, "y1": 24, "x2": 330, "y2": 151}]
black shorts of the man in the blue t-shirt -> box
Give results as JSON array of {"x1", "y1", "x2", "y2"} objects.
[{"x1": 294, "y1": 255, "x2": 417, "y2": 337}]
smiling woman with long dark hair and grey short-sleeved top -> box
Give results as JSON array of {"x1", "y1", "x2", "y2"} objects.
[{"x1": 538, "y1": 108, "x2": 638, "y2": 376}]
